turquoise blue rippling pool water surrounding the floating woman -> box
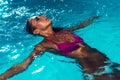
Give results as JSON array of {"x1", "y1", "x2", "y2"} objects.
[{"x1": 0, "y1": 0, "x2": 120, "y2": 80}]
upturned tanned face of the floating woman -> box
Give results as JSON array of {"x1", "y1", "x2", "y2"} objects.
[{"x1": 29, "y1": 16, "x2": 52, "y2": 30}]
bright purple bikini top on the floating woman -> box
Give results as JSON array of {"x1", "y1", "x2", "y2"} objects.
[{"x1": 46, "y1": 31, "x2": 83, "y2": 55}]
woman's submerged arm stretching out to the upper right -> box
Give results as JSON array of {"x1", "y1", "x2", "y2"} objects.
[{"x1": 66, "y1": 16, "x2": 99, "y2": 32}]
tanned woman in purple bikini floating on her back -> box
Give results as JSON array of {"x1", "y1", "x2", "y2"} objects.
[{"x1": 0, "y1": 16, "x2": 120, "y2": 80}]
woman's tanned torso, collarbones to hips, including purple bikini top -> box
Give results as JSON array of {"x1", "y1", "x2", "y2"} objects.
[{"x1": 38, "y1": 31, "x2": 118, "y2": 80}]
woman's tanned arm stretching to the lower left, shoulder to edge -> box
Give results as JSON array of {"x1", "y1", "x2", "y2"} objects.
[{"x1": 0, "y1": 44, "x2": 45, "y2": 80}]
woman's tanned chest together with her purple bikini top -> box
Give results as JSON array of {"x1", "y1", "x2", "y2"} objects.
[{"x1": 48, "y1": 34, "x2": 82, "y2": 53}]
